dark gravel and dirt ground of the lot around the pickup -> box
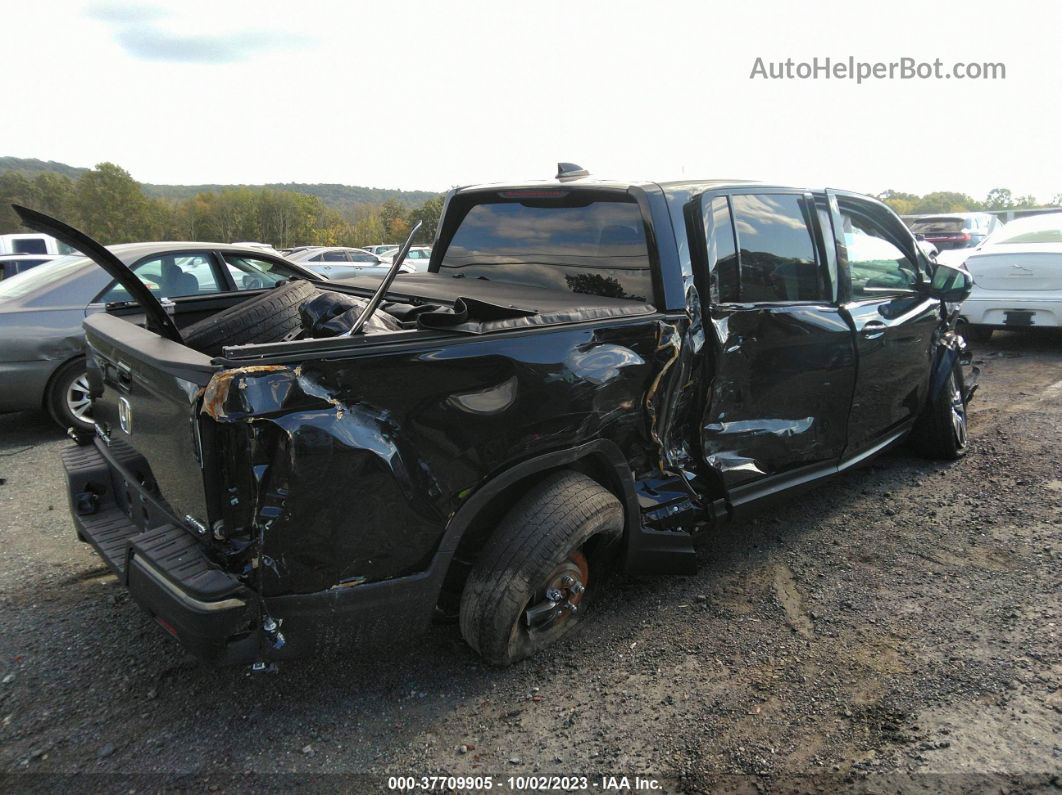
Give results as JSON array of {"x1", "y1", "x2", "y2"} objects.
[{"x1": 0, "y1": 333, "x2": 1062, "y2": 792}]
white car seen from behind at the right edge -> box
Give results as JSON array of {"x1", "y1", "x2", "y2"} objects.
[{"x1": 961, "y1": 211, "x2": 1062, "y2": 342}]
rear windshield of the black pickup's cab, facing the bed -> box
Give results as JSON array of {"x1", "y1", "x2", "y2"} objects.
[{"x1": 435, "y1": 191, "x2": 653, "y2": 301}]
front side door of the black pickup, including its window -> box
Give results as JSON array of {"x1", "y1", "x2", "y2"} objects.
[{"x1": 827, "y1": 191, "x2": 940, "y2": 457}]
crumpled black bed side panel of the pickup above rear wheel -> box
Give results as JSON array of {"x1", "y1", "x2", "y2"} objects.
[{"x1": 204, "y1": 321, "x2": 662, "y2": 595}]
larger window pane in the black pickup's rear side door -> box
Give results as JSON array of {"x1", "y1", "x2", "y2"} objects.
[{"x1": 731, "y1": 194, "x2": 825, "y2": 304}]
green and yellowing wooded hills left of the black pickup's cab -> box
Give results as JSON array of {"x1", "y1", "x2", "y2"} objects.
[{"x1": 0, "y1": 162, "x2": 443, "y2": 248}]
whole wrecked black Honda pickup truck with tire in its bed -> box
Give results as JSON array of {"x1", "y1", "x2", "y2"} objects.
[{"x1": 22, "y1": 170, "x2": 973, "y2": 666}]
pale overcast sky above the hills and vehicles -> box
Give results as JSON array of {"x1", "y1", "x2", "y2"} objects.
[{"x1": 0, "y1": 0, "x2": 1062, "y2": 200}]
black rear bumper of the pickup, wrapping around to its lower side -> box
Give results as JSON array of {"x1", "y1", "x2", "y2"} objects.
[{"x1": 63, "y1": 439, "x2": 442, "y2": 664}]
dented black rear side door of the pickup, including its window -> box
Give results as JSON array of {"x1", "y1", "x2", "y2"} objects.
[{"x1": 687, "y1": 191, "x2": 855, "y2": 506}]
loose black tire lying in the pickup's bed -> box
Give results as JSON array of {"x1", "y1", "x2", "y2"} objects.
[{"x1": 181, "y1": 279, "x2": 318, "y2": 356}]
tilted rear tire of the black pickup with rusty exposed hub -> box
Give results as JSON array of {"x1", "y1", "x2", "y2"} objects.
[{"x1": 460, "y1": 470, "x2": 623, "y2": 666}]
